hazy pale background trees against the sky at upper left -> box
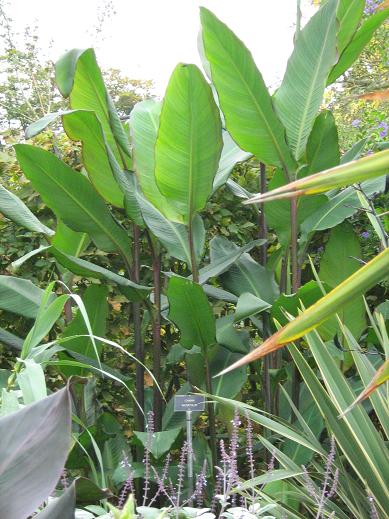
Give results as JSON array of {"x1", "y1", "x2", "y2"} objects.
[{"x1": 0, "y1": 0, "x2": 153, "y2": 134}]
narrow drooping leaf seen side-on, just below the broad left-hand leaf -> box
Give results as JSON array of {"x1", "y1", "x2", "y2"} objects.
[{"x1": 49, "y1": 247, "x2": 151, "y2": 301}]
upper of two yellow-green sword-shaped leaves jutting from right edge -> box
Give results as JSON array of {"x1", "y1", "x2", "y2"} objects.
[{"x1": 243, "y1": 150, "x2": 389, "y2": 204}]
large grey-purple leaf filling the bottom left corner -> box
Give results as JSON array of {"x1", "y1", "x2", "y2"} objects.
[{"x1": 0, "y1": 388, "x2": 71, "y2": 519}]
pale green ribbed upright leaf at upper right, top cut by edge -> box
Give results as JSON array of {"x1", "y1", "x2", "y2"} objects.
[{"x1": 275, "y1": 0, "x2": 338, "y2": 159}]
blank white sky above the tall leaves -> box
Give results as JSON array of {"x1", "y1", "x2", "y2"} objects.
[{"x1": 7, "y1": 0, "x2": 314, "y2": 96}]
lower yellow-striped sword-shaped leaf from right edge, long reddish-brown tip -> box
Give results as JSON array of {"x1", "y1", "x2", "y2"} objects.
[{"x1": 220, "y1": 248, "x2": 389, "y2": 374}]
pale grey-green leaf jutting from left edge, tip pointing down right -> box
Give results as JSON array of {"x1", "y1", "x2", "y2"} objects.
[{"x1": 0, "y1": 185, "x2": 54, "y2": 236}]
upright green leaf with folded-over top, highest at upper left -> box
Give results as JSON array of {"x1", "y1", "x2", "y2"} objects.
[{"x1": 55, "y1": 49, "x2": 131, "y2": 164}]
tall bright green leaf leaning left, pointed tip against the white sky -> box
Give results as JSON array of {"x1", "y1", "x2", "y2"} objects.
[{"x1": 201, "y1": 7, "x2": 295, "y2": 170}]
